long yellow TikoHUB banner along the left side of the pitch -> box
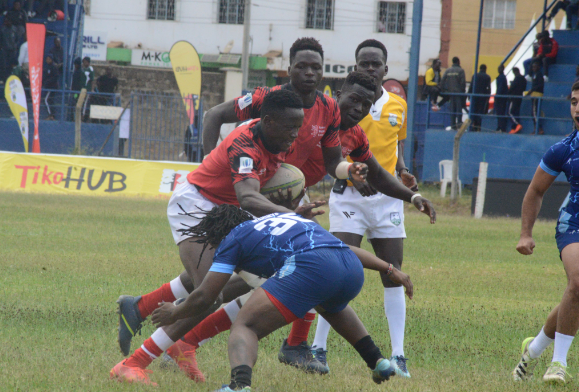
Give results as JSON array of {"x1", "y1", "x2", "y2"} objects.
[{"x1": 0, "y1": 151, "x2": 199, "y2": 197}]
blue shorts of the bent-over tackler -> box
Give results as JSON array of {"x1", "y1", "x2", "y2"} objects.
[{"x1": 261, "y1": 248, "x2": 364, "y2": 318}]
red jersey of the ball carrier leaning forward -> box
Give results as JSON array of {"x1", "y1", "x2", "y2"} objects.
[{"x1": 187, "y1": 120, "x2": 293, "y2": 206}]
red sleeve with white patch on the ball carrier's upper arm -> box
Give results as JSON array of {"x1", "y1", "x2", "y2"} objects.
[{"x1": 227, "y1": 135, "x2": 260, "y2": 185}]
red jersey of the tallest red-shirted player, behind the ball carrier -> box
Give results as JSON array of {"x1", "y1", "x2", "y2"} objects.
[{"x1": 235, "y1": 83, "x2": 341, "y2": 172}]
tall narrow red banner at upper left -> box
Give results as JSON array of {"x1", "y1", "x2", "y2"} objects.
[{"x1": 26, "y1": 23, "x2": 46, "y2": 152}]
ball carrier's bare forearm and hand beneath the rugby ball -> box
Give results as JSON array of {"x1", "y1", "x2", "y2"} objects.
[{"x1": 233, "y1": 178, "x2": 326, "y2": 219}]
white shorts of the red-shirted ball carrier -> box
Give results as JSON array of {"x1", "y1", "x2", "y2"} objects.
[{"x1": 167, "y1": 181, "x2": 217, "y2": 245}]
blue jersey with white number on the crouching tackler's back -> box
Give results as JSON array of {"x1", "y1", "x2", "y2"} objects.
[{"x1": 209, "y1": 213, "x2": 348, "y2": 278}]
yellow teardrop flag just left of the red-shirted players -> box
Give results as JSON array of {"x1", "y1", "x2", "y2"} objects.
[{"x1": 170, "y1": 41, "x2": 201, "y2": 114}]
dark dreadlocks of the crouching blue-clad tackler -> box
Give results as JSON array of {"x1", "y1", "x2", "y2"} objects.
[{"x1": 177, "y1": 204, "x2": 253, "y2": 268}]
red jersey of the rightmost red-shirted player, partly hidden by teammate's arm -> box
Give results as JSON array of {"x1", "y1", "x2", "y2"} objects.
[{"x1": 301, "y1": 125, "x2": 374, "y2": 187}]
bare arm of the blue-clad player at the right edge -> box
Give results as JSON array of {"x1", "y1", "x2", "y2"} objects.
[{"x1": 517, "y1": 166, "x2": 557, "y2": 255}]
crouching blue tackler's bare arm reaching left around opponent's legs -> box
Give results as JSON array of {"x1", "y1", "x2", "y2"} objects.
[{"x1": 151, "y1": 272, "x2": 231, "y2": 328}]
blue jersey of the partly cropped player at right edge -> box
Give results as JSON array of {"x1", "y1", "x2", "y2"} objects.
[{"x1": 539, "y1": 130, "x2": 579, "y2": 234}]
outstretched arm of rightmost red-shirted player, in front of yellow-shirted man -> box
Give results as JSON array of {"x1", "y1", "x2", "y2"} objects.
[{"x1": 366, "y1": 157, "x2": 436, "y2": 223}]
